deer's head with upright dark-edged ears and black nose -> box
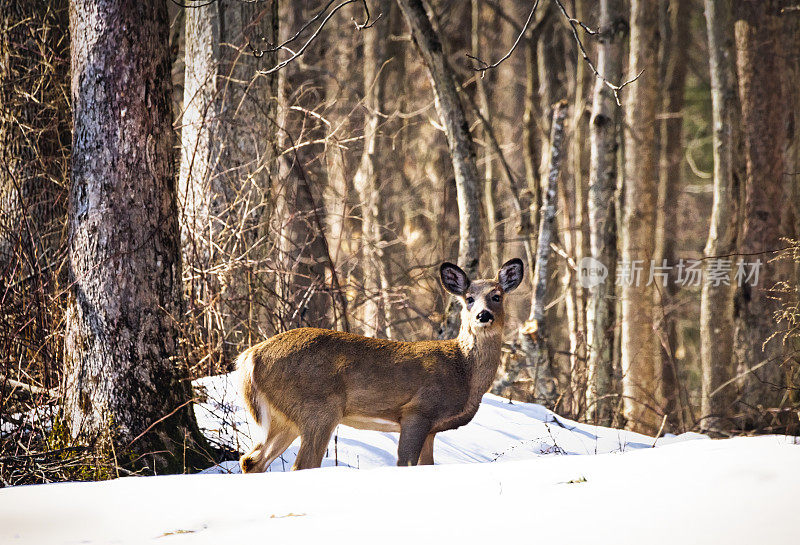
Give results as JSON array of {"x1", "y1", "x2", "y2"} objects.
[{"x1": 439, "y1": 258, "x2": 524, "y2": 334}]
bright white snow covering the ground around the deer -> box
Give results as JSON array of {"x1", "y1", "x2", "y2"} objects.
[{"x1": 0, "y1": 377, "x2": 800, "y2": 545}]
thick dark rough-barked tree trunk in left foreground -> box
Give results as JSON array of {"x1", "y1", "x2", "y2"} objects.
[{"x1": 64, "y1": 0, "x2": 204, "y2": 473}]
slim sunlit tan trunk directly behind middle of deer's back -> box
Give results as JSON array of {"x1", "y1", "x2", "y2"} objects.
[{"x1": 353, "y1": 0, "x2": 391, "y2": 338}]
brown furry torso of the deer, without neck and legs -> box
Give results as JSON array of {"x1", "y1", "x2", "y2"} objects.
[{"x1": 250, "y1": 328, "x2": 469, "y2": 421}]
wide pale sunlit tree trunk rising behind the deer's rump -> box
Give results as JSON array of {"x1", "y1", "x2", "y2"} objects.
[{"x1": 179, "y1": 0, "x2": 278, "y2": 363}]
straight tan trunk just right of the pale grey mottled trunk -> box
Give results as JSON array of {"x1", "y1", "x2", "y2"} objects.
[{"x1": 621, "y1": 0, "x2": 661, "y2": 433}]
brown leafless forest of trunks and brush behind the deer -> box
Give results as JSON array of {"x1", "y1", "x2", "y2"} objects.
[{"x1": 0, "y1": 0, "x2": 800, "y2": 487}]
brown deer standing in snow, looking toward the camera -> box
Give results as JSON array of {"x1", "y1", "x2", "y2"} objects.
[{"x1": 236, "y1": 259, "x2": 524, "y2": 473}]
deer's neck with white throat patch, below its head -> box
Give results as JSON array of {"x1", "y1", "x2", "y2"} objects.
[{"x1": 456, "y1": 320, "x2": 503, "y2": 407}]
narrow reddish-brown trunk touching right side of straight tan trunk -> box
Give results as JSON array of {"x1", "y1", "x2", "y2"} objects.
[{"x1": 655, "y1": 0, "x2": 689, "y2": 430}]
